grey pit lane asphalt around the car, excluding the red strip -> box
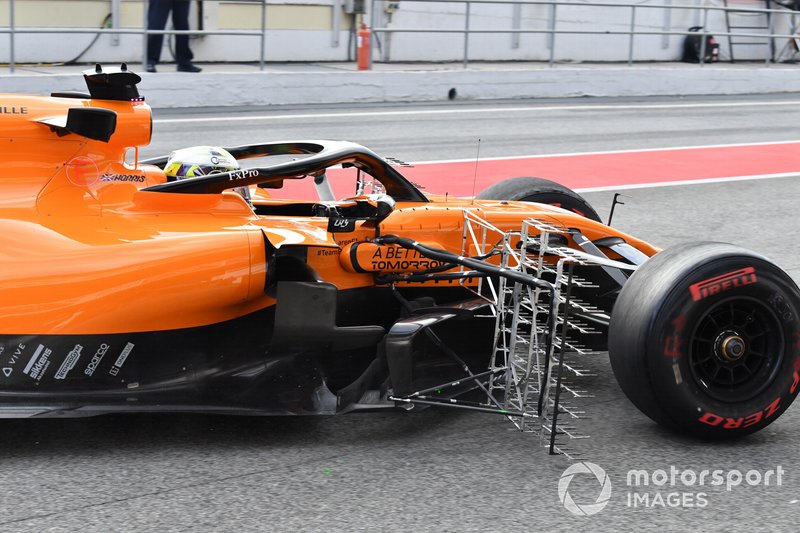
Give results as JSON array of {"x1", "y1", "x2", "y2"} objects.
[{"x1": 0, "y1": 96, "x2": 800, "y2": 532}]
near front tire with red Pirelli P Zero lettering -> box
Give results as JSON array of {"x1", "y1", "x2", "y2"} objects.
[{"x1": 608, "y1": 242, "x2": 800, "y2": 439}]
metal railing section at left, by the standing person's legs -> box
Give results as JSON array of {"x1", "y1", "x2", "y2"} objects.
[{"x1": 0, "y1": 0, "x2": 267, "y2": 72}]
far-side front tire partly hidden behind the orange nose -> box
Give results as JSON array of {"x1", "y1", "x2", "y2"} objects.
[{"x1": 475, "y1": 177, "x2": 602, "y2": 222}]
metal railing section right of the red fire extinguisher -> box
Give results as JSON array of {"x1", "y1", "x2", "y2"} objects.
[{"x1": 370, "y1": 0, "x2": 798, "y2": 68}]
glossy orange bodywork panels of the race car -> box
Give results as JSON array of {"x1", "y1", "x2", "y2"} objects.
[{"x1": 0, "y1": 90, "x2": 658, "y2": 335}]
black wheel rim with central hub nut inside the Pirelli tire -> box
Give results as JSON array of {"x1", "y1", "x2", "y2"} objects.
[{"x1": 688, "y1": 296, "x2": 784, "y2": 402}]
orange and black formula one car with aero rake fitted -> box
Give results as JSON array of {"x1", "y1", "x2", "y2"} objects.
[{"x1": 0, "y1": 65, "x2": 800, "y2": 450}]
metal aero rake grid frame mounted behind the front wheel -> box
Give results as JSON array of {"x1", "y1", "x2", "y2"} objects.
[{"x1": 386, "y1": 209, "x2": 636, "y2": 458}]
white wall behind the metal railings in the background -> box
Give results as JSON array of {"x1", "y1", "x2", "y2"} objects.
[{"x1": 0, "y1": 0, "x2": 788, "y2": 63}]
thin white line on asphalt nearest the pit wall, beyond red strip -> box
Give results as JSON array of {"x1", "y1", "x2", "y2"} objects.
[{"x1": 153, "y1": 100, "x2": 800, "y2": 124}]
